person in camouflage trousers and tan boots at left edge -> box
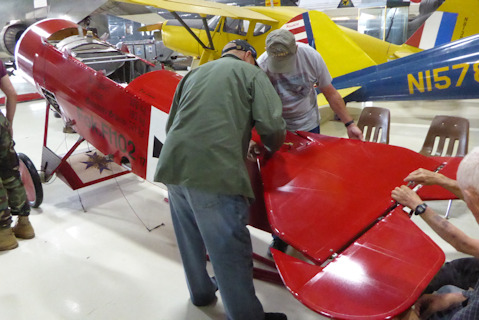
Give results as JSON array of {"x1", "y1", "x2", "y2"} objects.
[{"x1": 0, "y1": 61, "x2": 35, "y2": 251}]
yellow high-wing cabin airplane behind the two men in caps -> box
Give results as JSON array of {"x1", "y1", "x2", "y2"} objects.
[{"x1": 117, "y1": 0, "x2": 307, "y2": 64}]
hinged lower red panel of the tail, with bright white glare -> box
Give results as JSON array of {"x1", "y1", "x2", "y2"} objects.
[{"x1": 273, "y1": 207, "x2": 444, "y2": 320}]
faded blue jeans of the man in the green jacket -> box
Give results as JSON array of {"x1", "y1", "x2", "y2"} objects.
[{"x1": 168, "y1": 185, "x2": 264, "y2": 320}]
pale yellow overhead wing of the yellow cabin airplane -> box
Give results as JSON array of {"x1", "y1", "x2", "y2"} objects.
[{"x1": 116, "y1": 0, "x2": 276, "y2": 23}]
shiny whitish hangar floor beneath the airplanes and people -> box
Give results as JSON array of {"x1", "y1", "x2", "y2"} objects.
[{"x1": 0, "y1": 74, "x2": 479, "y2": 320}]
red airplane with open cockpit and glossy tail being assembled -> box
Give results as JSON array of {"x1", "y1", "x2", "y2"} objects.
[{"x1": 15, "y1": 19, "x2": 460, "y2": 319}]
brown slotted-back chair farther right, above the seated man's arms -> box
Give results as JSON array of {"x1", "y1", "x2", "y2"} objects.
[{"x1": 419, "y1": 116, "x2": 469, "y2": 219}]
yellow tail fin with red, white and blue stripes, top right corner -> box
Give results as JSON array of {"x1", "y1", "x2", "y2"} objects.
[{"x1": 406, "y1": 0, "x2": 479, "y2": 50}]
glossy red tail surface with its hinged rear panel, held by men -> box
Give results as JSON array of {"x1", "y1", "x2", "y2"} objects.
[{"x1": 261, "y1": 132, "x2": 448, "y2": 319}]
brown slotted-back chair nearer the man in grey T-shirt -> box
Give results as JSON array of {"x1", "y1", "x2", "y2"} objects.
[{"x1": 358, "y1": 107, "x2": 391, "y2": 144}]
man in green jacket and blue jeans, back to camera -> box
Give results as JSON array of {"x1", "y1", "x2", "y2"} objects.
[{"x1": 155, "y1": 40, "x2": 287, "y2": 320}]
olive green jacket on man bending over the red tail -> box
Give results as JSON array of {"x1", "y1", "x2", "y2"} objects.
[{"x1": 155, "y1": 55, "x2": 286, "y2": 198}]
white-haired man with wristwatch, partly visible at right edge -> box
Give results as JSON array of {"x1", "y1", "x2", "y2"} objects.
[{"x1": 392, "y1": 147, "x2": 479, "y2": 320}]
